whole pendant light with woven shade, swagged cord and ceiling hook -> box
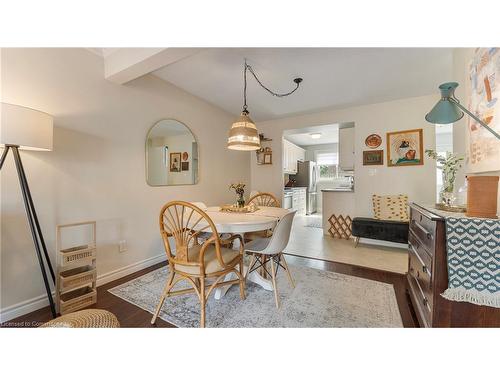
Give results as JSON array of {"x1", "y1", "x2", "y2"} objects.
[{"x1": 227, "y1": 60, "x2": 302, "y2": 151}]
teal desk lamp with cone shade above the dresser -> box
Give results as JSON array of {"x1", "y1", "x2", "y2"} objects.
[{"x1": 425, "y1": 82, "x2": 500, "y2": 139}]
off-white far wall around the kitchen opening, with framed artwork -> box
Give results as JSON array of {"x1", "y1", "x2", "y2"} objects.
[{"x1": 251, "y1": 94, "x2": 439, "y2": 216}]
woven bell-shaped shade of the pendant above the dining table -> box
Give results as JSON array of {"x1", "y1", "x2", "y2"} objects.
[{"x1": 227, "y1": 111, "x2": 260, "y2": 151}]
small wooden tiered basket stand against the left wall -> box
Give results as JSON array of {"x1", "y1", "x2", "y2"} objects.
[{"x1": 56, "y1": 221, "x2": 97, "y2": 315}]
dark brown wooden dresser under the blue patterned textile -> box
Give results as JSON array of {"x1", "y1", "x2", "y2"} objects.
[{"x1": 407, "y1": 203, "x2": 500, "y2": 327}]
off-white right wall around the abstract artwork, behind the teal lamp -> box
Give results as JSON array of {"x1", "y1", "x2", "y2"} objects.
[{"x1": 453, "y1": 48, "x2": 500, "y2": 214}]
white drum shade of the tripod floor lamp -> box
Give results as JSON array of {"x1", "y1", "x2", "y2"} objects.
[{"x1": 0, "y1": 103, "x2": 54, "y2": 151}]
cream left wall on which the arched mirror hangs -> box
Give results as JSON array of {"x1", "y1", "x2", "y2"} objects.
[{"x1": 0, "y1": 49, "x2": 249, "y2": 320}]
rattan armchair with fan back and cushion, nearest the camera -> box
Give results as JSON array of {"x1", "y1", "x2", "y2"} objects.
[{"x1": 151, "y1": 201, "x2": 245, "y2": 327}]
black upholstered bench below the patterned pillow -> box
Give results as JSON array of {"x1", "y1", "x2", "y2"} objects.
[{"x1": 352, "y1": 217, "x2": 409, "y2": 246}]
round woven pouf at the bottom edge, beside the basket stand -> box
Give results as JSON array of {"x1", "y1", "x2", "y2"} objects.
[{"x1": 40, "y1": 309, "x2": 120, "y2": 328}]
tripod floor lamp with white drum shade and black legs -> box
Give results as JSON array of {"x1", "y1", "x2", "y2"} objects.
[{"x1": 0, "y1": 103, "x2": 56, "y2": 318}]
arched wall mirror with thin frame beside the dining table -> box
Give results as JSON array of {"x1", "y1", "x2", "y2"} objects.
[{"x1": 146, "y1": 119, "x2": 198, "y2": 186}]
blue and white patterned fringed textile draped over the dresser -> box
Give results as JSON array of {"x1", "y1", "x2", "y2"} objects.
[{"x1": 442, "y1": 217, "x2": 500, "y2": 307}]
